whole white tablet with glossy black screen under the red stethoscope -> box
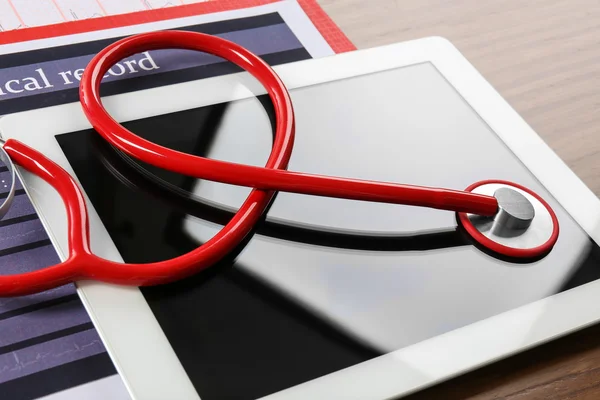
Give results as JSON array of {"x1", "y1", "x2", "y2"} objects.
[{"x1": 0, "y1": 38, "x2": 600, "y2": 400}]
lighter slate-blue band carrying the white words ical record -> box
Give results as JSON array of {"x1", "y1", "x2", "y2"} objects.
[{"x1": 0, "y1": 24, "x2": 302, "y2": 101}]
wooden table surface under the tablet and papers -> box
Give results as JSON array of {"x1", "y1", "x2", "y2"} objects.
[{"x1": 318, "y1": 0, "x2": 600, "y2": 400}]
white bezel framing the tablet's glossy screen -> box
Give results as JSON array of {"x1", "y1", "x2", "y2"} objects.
[{"x1": 0, "y1": 38, "x2": 600, "y2": 400}]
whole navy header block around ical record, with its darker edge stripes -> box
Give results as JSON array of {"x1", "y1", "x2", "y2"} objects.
[{"x1": 0, "y1": 13, "x2": 311, "y2": 115}]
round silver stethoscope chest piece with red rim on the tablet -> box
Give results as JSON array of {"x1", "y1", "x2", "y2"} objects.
[{"x1": 458, "y1": 181, "x2": 558, "y2": 259}]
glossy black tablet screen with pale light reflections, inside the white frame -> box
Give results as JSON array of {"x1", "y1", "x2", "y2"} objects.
[{"x1": 57, "y1": 64, "x2": 600, "y2": 400}]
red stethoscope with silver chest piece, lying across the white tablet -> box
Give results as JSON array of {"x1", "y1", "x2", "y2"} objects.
[{"x1": 0, "y1": 31, "x2": 559, "y2": 296}]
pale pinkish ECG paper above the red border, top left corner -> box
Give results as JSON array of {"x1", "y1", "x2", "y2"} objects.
[{"x1": 0, "y1": 0, "x2": 215, "y2": 31}]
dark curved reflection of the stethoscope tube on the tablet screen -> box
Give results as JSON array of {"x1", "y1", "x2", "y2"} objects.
[{"x1": 92, "y1": 137, "x2": 473, "y2": 252}]
